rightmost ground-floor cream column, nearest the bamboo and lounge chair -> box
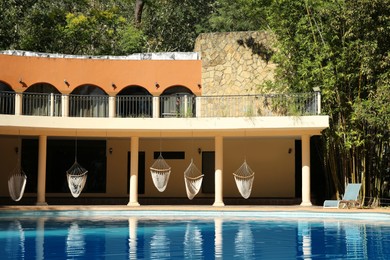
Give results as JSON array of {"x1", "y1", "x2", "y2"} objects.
[{"x1": 301, "y1": 135, "x2": 312, "y2": 206}]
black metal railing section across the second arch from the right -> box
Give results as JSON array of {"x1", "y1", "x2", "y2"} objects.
[{"x1": 116, "y1": 95, "x2": 153, "y2": 118}]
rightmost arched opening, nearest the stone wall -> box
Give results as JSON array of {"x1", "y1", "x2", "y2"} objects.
[{"x1": 160, "y1": 86, "x2": 196, "y2": 117}]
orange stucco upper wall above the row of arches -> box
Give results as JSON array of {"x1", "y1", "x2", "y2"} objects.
[{"x1": 0, "y1": 54, "x2": 202, "y2": 96}]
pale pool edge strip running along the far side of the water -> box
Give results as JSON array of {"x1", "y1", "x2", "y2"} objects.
[{"x1": 0, "y1": 205, "x2": 390, "y2": 220}]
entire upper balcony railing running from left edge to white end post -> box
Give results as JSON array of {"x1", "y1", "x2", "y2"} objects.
[{"x1": 0, "y1": 91, "x2": 321, "y2": 118}]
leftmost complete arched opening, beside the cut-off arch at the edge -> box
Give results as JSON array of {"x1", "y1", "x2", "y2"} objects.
[{"x1": 22, "y1": 83, "x2": 61, "y2": 116}]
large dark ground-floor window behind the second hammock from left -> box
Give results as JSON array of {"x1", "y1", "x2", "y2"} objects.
[{"x1": 22, "y1": 139, "x2": 106, "y2": 193}]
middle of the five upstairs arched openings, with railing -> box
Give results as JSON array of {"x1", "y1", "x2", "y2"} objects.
[{"x1": 69, "y1": 85, "x2": 108, "y2": 117}]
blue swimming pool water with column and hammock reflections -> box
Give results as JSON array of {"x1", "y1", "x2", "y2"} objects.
[{"x1": 0, "y1": 212, "x2": 390, "y2": 260}]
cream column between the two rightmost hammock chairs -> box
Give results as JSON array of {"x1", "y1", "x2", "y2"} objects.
[{"x1": 213, "y1": 136, "x2": 225, "y2": 206}]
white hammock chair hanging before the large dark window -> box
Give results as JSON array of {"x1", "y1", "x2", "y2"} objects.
[{"x1": 66, "y1": 161, "x2": 88, "y2": 198}]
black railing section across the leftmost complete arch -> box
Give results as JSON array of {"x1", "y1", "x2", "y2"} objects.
[{"x1": 22, "y1": 93, "x2": 61, "y2": 116}]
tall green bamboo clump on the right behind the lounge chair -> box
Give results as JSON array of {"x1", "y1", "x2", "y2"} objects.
[{"x1": 268, "y1": 0, "x2": 390, "y2": 203}]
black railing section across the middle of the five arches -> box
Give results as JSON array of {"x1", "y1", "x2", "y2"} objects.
[{"x1": 69, "y1": 95, "x2": 108, "y2": 117}]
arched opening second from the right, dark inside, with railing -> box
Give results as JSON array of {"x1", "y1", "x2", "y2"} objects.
[{"x1": 116, "y1": 86, "x2": 153, "y2": 117}]
